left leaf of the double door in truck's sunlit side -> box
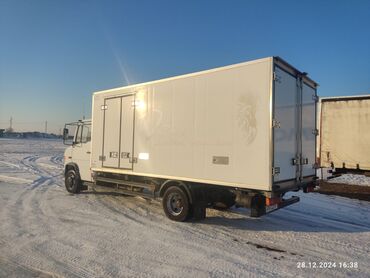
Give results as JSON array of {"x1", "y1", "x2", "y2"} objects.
[{"x1": 103, "y1": 98, "x2": 121, "y2": 168}]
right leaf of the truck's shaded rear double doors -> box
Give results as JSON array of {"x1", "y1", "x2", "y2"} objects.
[{"x1": 302, "y1": 84, "x2": 316, "y2": 177}]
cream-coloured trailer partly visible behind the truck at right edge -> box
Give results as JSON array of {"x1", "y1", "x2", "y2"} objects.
[{"x1": 319, "y1": 95, "x2": 370, "y2": 173}]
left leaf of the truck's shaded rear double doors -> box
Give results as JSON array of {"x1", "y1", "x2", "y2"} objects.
[{"x1": 274, "y1": 67, "x2": 298, "y2": 181}]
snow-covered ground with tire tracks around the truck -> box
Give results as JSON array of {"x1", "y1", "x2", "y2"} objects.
[{"x1": 0, "y1": 139, "x2": 370, "y2": 277}]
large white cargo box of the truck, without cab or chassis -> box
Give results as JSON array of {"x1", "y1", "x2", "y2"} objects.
[{"x1": 91, "y1": 57, "x2": 317, "y2": 191}]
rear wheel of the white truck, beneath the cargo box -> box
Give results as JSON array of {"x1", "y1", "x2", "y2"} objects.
[{"x1": 162, "y1": 186, "x2": 190, "y2": 222}]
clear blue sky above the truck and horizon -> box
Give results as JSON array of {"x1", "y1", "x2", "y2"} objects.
[{"x1": 0, "y1": 0, "x2": 370, "y2": 132}]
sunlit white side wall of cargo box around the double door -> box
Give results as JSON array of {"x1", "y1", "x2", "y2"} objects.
[{"x1": 91, "y1": 58, "x2": 272, "y2": 191}]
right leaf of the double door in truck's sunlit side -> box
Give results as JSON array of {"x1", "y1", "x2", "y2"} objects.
[{"x1": 119, "y1": 95, "x2": 134, "y2": 169}]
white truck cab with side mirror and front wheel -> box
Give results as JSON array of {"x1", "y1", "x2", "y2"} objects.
[{"x1": 63, "y1": 120, "x2": 92, "y2": 193}]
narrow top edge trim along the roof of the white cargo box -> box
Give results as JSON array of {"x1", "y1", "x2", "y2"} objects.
[{"x1": 94, "y1": 56, "x2": 318, "y2": 95}]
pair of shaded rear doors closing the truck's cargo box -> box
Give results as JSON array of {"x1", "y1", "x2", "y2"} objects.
[{"x1": 272, "y1": 66, "x2": 316, "y2": 185}]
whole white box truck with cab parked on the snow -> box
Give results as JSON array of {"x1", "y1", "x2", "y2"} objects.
[{"x1": 64, "y1": 57, "x2": 318, "y2": 221}]
